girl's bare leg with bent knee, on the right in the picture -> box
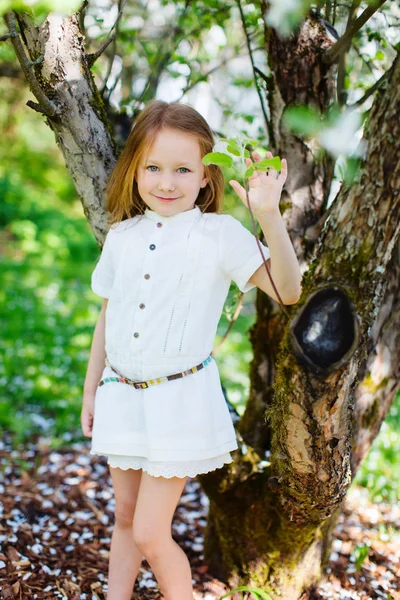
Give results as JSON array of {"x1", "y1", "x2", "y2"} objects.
[{"x1": 133, "y1": 472, "x2": 193, "y2": 600}]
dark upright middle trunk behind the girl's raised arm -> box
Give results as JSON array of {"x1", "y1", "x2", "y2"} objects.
[{"x1": 239, "y1": 9, "x2": 336, "y2": 472}]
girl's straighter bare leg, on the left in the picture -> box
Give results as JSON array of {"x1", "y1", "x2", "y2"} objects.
[{"x1": 107, "y1": 467, "x2": 143, "y2": 600}]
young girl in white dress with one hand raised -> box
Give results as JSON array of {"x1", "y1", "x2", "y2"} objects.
[{"x1": 81, "y1": 100, "x2": 299, "y2": 600}]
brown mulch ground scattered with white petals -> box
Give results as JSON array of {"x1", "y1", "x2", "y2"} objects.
[{"x1": 0, "y1": 437, "x2": 400, "y2": 600}]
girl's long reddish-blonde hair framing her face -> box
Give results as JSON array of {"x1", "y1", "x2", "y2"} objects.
[{"x1": 106, "y1": 100, "x2": 224, "y2": 225}]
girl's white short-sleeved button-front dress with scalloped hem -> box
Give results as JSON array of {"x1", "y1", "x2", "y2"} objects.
[{"x1": 90, "y1": 205, "x2": 269, "y2": 477}]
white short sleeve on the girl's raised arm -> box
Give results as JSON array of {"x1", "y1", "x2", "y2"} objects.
[{"x1": 219, "y1": 215, "x2": 270, "y2": 292}]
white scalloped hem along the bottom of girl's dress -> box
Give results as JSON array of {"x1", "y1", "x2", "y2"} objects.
[{"x1": 90, "y1": 451, "x2": 233, "y2": 479}]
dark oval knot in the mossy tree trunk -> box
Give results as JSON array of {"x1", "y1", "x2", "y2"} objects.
[{"x1": 290, "y1": 286, "x2": 359, "y2": 375}]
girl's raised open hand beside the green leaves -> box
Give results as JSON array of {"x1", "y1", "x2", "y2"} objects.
[{"x1": 229, "y1": 152, "x2": 287, "y2": 215}]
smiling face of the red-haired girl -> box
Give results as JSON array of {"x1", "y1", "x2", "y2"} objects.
[{"x1": 135, "y1": 128, "x2": 208, "y2": 216}]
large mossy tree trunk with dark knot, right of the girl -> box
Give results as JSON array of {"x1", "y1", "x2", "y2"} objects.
[{"x1": 198, "y1": 20, "x2": 400, "y2": 600}]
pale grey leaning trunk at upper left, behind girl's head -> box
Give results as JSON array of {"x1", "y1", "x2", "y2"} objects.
[{"x1": 11, "y1": 13, "x2": 116, "y2": 245}]
